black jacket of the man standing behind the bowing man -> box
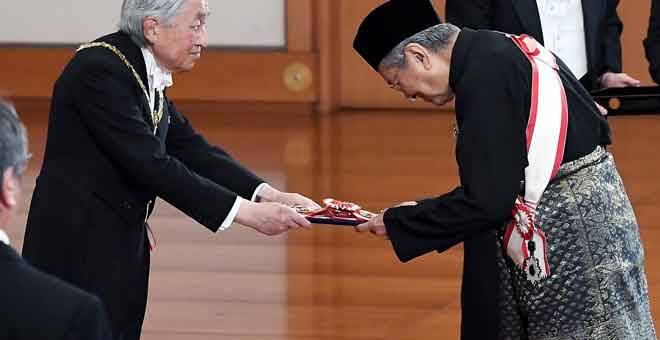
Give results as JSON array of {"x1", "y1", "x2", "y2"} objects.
[{"x1": 445, "y1": 0, "x2": 623, "y2": 90}]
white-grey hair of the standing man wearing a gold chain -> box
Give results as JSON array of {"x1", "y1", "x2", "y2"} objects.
[{"x1": 119, "y1": 0, "x2": 187, "y2": 47}]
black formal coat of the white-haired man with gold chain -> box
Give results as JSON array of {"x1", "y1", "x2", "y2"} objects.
[{"x1": 23, "y1": 32, "x2": 263, "y2": 331}]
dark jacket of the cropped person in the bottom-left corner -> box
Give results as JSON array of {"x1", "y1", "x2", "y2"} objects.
[{"x1": 0, "y1": 242, "x2": 111, "y2": 340}]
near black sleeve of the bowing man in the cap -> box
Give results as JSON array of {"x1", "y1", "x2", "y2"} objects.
[{"x1": 384, "y1": 56, "x2": 531, "y2": 262}]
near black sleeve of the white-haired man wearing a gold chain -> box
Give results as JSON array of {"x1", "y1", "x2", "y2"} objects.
[{"x1": 73, "y1": 51, "x2": 237, "y2": 231}]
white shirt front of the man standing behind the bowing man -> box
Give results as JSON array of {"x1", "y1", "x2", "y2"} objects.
[{"x1": 536, "y1": 0, "x2": 588, "y2": 79}]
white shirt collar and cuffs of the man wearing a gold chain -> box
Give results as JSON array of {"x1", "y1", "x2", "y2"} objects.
[{"x1": 142, "y1": 48, "x2": 267, "y2": 231}]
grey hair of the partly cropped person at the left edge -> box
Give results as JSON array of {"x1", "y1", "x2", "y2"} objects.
[{"x1": 0, "y1": 98, "x2": 30, "y2": 183}]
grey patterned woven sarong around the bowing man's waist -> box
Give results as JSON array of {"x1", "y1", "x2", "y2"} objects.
[{"x1": 496, "y1": 147, "x2": 656, "y2": 340}]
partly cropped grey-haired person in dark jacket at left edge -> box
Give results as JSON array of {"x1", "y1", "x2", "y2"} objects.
[{"x1": 0, "y1": 99, "x2": 111, "y2": 340}]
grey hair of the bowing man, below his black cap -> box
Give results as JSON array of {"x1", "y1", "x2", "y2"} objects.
[{"x1": 380, "y1": 23, "x2": 461, "y2": 68}]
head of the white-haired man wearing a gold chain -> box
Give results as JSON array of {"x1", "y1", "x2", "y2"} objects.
[{"x1": 119, "y1": 0, "x2": 210, "y2": 72}]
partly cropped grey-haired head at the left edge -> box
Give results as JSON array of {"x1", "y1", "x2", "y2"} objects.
[{"x1": 0, "y1": 98, "x2": 29, "y2": 231}]
